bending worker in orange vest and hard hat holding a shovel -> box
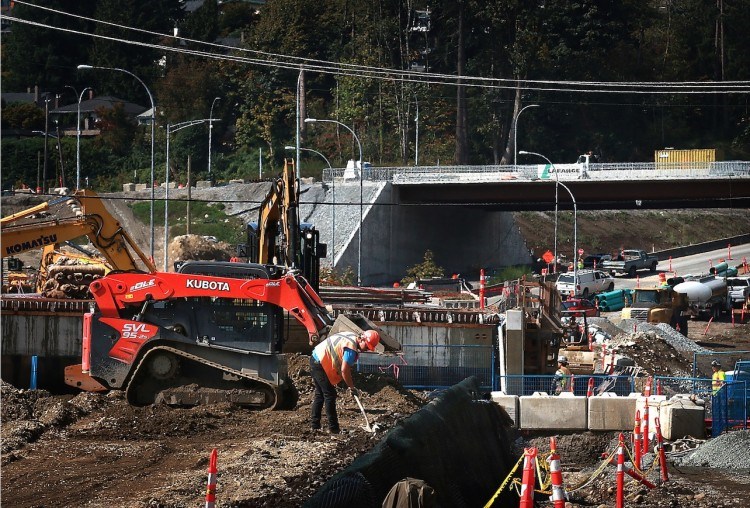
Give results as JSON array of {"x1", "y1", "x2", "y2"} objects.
[{"x1": 310, "y1": 330, "x2": 380, "y2": 434}]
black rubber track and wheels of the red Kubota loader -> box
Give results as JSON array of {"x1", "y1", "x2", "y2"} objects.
[{"x1": 125, "y1": 346, "x2": 296, "y2": 409}]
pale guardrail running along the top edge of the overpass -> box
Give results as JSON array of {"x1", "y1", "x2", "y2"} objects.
[{"x1": 323, "y1": 161, "x2": 750, "y2": 184}]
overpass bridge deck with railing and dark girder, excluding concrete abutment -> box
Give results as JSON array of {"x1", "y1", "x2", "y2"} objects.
[{"x1": 365, "y1": 161, "x2": 750, "y2": 211}]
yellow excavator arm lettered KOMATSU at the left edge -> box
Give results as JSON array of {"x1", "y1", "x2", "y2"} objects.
[{"x1": 0, "y1": 190, "x2": 156, "y2": 272}]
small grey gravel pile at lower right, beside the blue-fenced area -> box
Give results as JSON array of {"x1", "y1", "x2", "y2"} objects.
[{"x1": 675, "y1": 430, "x2": 750, "y2": 470}]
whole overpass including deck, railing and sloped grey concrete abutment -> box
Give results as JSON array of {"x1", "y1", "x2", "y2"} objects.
[{"x1": 318, "y1": 161, "x2": 750, "y2": 285}]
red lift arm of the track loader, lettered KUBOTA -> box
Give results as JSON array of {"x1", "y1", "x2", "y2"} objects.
[{"x1": 90, "y1": 272, "x2": 333, "y2": 343}]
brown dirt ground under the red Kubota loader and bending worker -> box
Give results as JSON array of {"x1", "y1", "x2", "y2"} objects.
[{"x1": 1, "y1": 355, "x2": 427, "y2": 507}]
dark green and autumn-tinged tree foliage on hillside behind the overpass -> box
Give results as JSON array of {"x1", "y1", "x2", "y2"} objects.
[{"x1": 2, "y1": 0, "x2": 750, "y2": 190}]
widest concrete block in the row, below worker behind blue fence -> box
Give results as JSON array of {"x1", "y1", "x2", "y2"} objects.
[{"x1": 519, "y1": 392, "x2": 588, "y2": 430}]
